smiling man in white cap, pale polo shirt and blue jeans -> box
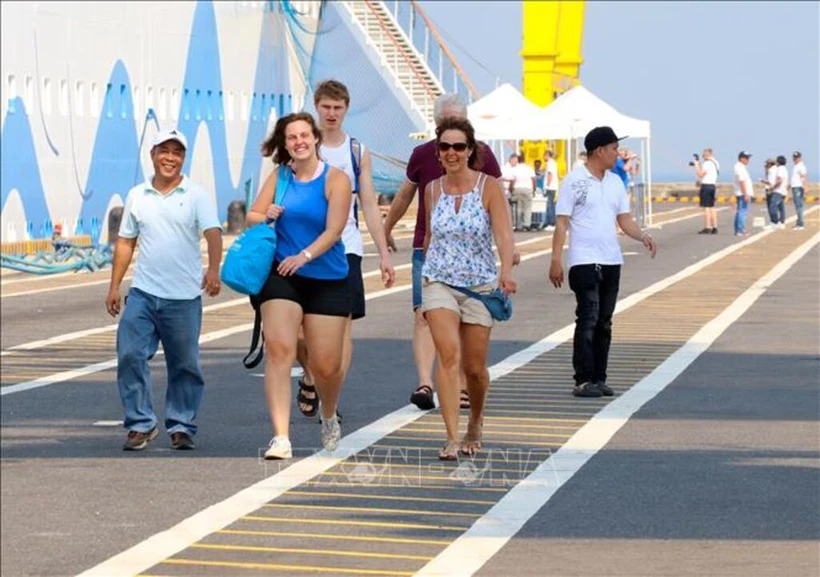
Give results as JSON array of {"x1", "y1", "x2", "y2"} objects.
[{"x1": 105, "y1": 130, "x2": 222, "y2": 451}]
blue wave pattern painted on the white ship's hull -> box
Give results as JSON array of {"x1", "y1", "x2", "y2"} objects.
[{"x1": 0, "y1": 1, "x2": 290, "y2": 236}]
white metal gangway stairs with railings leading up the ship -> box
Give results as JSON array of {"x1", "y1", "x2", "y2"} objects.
[{"x1": 342, "y1": 0, "x2": 478, "y2": 132}]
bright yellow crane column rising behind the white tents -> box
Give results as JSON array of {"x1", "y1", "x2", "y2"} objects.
[{"x1": 521, "y1": 0, "x2": 585, "y2": 174}]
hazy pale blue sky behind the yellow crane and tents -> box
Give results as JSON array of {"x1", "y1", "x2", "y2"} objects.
[{"x1": 421, "y1": 0, "x2": 820, "y2": 182}]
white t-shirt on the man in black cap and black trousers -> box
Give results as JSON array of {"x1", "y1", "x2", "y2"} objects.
[{"x1": 555, "y1": 166, "x2": 630, "y2": 268}]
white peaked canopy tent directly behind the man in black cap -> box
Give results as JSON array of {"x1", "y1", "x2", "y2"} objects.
[{"x1": 542, "y1": 86, "x2": 652, "y2": 223}]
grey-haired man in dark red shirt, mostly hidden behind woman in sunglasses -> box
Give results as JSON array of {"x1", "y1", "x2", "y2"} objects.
[{"x1": 384, "y1": 94, "x2": 501, "y2": 410}]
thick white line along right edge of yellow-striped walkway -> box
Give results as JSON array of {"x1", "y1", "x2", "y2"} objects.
[{"x1": 416, "y1": 233, "x2": 820, "y2": 577}]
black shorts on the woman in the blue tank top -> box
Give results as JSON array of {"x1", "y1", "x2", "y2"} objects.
[{"x1": 251, "y1": 262, "x2": 350, "y2": 317}]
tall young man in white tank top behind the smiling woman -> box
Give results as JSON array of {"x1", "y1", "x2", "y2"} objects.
[{"x1": 297, "y1": 80, "x2": 396, "y2": 416}]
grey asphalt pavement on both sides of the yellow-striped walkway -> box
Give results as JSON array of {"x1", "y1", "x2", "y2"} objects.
[{"x1": 0, "y1": 207, "x2": 820, "y2": 576}]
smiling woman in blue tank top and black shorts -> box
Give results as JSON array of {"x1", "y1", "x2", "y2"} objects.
[{"x1": 247, "y1": 113, "x2": 351, "y2": 459}]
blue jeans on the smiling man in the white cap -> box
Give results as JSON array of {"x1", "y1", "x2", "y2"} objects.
[{"x1": 117, "y1": 288, "x2": 205, "y2": 436}]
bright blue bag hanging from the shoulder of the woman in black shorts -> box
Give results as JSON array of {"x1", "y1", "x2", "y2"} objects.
[{"x1": 220, "y1": 165, "x2": 292, "y2": 295}]
